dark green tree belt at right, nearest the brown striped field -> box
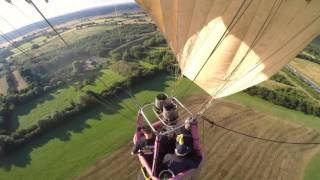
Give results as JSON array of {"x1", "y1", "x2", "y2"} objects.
[{"x1": 244, "y1": 86, "x2": 320, "y2": 117}]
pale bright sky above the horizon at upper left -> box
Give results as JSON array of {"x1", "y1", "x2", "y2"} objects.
[{"x1": 0, "y1": 0, "x2": 134, "y2": 33}]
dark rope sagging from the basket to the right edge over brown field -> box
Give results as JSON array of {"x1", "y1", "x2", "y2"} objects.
[{"x1": 200, "y1": 115, "x2": 320, "y2": 145}]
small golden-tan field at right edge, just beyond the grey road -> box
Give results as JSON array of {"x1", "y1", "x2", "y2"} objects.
[{"x1": 290, "y1": 58, "x2": 320, "y2": 85}]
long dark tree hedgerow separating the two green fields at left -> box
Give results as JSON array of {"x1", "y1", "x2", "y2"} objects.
[{"x1": 0, "y1": 65, "x2": 161, "y2": 154}]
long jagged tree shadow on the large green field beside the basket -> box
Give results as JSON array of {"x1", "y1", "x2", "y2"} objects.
[{"x1": 0, "y1": 73, "x2": 169, "y2": 171}]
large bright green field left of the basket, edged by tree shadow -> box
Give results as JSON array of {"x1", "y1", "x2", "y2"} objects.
[{"x1": 0, "y1": 74, "x2": 200, "y2": 180}]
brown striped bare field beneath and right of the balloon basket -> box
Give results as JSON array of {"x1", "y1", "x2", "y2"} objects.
[{"x1": 78, "y1": 96, "x2": 320, "y2": 180}]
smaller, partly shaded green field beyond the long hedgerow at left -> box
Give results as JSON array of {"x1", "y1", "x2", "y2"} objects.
[{"x1": 11, "y1": 69, "x2": 125, "y2": 129}]
